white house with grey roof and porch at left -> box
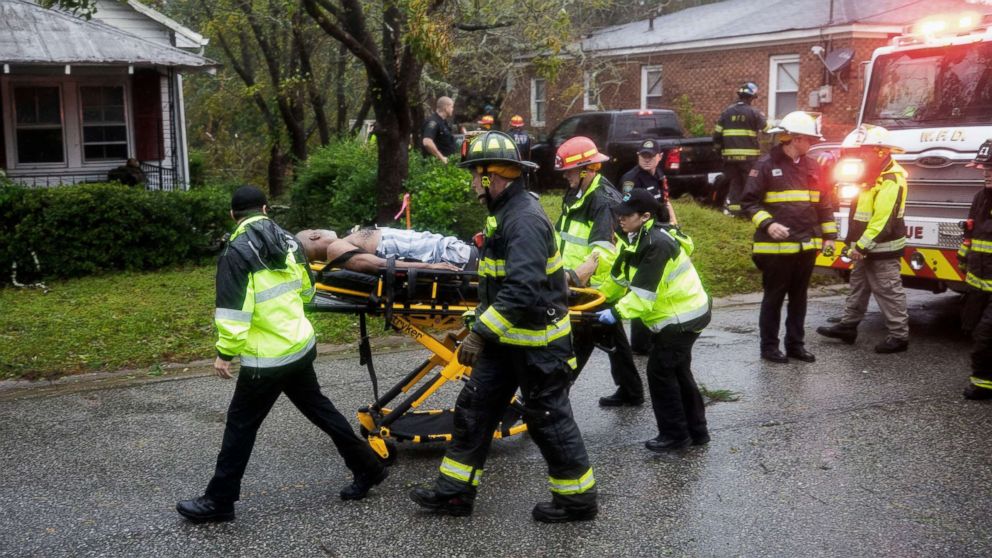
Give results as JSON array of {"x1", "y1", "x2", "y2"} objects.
[{"x1": 0, "y1": 0, "x2": 217, "y2": 190}]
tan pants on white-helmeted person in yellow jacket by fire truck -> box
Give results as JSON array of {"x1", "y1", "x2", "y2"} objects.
[{"x1": 840, "y1": 258, "x2": 909, "y2": 340}]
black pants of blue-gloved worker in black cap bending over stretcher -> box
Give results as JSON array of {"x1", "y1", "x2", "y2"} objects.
[{"x1": 648, "y1": 331, "x2": 707, "y2": 440}]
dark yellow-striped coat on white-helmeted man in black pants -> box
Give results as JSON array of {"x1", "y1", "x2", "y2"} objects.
[{"x1": 741, "y1": 145, "x2": 837, "y2": 254}]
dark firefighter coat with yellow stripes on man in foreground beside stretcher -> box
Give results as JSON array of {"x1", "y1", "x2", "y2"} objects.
[{"x1": 472, "y1": 179, "x2": 572, "y2": 360}]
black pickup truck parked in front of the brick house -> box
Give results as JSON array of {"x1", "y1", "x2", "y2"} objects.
[{"x1": 531, "y1": 109, "x2": 723, "y2": 199}]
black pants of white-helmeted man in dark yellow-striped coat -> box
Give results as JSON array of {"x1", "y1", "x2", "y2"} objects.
[{"x1": 753, "y1": 250, "x2": 816, "y2": 352}]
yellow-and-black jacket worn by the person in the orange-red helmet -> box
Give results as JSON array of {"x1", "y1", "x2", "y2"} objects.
[{"x1": 555, "y1": 174, "x2": 617, "y2": 287}]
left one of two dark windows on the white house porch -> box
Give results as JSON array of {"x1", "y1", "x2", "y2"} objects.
[{"x1": 14, "y1": 86, "x2": 65, "y2": 164}]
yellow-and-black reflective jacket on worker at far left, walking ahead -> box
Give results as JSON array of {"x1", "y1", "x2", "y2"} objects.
[{"x1": 214, "y1": 215, "x2": 316, "y2": 368}]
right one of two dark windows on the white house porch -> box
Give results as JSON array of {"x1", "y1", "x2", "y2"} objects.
[{"x1": 79, "y1": 86, "x2": 127, "y2": 162}]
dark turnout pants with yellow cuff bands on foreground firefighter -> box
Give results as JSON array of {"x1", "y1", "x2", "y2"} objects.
[{"x1": 434, "y1": 343, "x2": 596, "y2": 508}]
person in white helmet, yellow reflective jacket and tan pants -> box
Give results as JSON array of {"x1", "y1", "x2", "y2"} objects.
[{"x1": 816, "y1": 124, "x2": 909, "y2": 354}]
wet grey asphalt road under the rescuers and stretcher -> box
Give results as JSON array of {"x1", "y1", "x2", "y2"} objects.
[{"x1": 0, "y1": 292, "x2": 992, "y2": 557}]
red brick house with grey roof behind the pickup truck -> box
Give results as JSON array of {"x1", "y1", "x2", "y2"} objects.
[{"x1": 503, "y1": 0, "x2": 992, "y2": 140}]
